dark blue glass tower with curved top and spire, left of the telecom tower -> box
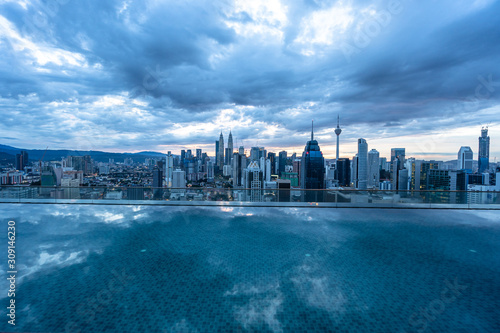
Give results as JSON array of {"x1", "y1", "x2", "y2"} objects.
[{"x1": 298, "y1": 123, "x2": 325, "y2": 202}]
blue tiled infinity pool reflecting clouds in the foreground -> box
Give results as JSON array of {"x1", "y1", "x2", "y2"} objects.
[{"x1": 0, "y1": 204, "x2": 500, "y2": 332}]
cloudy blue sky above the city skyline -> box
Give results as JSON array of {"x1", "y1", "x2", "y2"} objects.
[{"x1": 0, "y1": 0, "x2": 500, "y2": 161}]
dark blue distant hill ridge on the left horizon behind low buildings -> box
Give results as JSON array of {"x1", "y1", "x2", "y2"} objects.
[{"x1": 0, "y1": 145, "x2": 166, "y2": 164}]
